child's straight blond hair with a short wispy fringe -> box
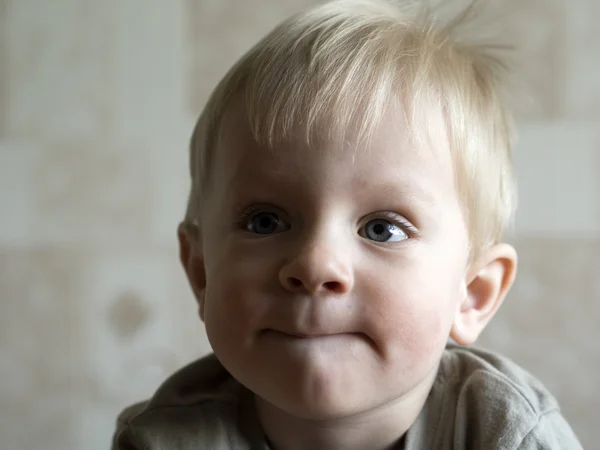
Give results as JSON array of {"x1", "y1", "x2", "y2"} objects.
[{"x1": 186, "y1": 0, "x2": 516, "y2": 262}]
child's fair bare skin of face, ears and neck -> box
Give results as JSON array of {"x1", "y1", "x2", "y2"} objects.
[{"x1": 179, "y1": 99, "x2": 516, "y2": 450}]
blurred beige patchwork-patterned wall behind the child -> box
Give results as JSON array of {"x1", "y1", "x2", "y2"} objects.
[{"x1": 0, "y1": 0, "x2": 600, "y2": 450}]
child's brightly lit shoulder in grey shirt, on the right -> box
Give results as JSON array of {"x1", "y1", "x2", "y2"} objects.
[{"x1": 409, "y1": 344, "x2": 581, "y2": 450}]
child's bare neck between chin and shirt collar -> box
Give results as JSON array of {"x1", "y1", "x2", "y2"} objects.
[{"x1": 256, "y1": 372, "x2": 433, "y2": 450}]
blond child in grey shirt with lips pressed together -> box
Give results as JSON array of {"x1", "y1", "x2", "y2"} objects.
[{"x1": 113, "y1": 0, "x2": 581, "y2": 450}]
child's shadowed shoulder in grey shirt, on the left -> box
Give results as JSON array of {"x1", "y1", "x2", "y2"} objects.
[{"x1": 113, "y1": 355, "x2": 262, "y2": 449}]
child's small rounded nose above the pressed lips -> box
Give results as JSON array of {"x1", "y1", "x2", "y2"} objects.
[{"x1": 279, "y1": 236, "x2": 354, "y2": 295}]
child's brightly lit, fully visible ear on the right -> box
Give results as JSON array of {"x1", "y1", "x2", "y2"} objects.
[{"x1": 450, "y1": 244, "x2": 517, "y2": 345}]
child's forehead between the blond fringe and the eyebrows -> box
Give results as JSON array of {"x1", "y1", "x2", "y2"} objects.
[{"x1": 213, "y1": 98, "x2": 454, "y2": 200}]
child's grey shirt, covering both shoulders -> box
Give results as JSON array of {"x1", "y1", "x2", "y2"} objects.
[{"x1": 113, "y1": 344, "x2": 581, "y2": 450}]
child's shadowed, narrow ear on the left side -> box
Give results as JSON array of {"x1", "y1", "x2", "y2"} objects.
[{"x1": 177, "y1": 222, "x2": 206, "y2": 320}]
